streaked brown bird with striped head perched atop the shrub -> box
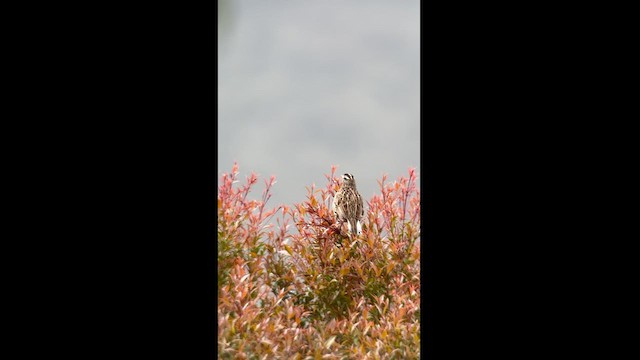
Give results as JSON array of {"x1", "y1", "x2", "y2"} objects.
[{"x1": 333, "y1": 174, "x2": 364, "y2": 235}]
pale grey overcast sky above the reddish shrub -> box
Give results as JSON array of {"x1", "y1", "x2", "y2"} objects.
[{"x1": 218, "y1": 0, "x2": 420, "y2": 207}]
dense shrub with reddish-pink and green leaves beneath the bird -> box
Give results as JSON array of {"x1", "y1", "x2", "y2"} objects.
[{"x1": 218, "y1": 164, "x2": 420, "y2": 359}]
